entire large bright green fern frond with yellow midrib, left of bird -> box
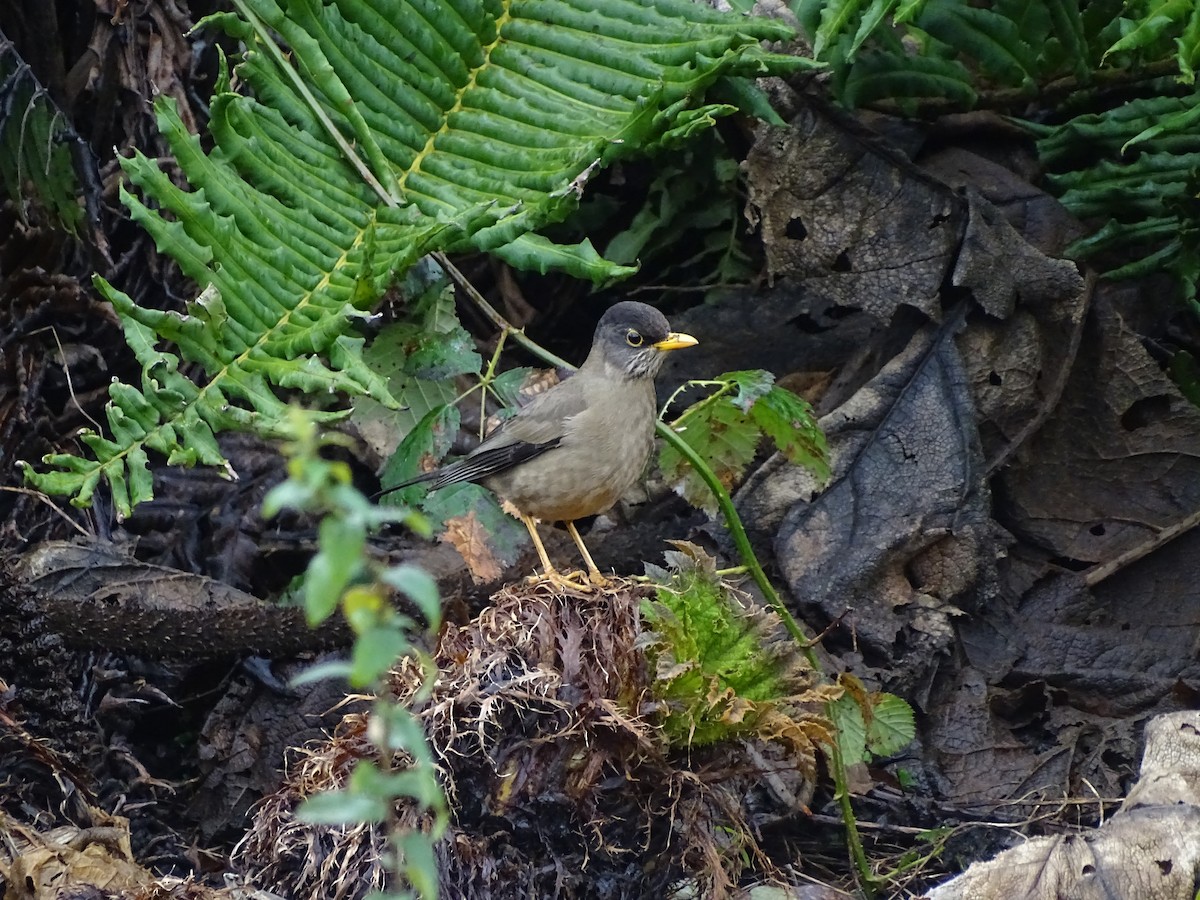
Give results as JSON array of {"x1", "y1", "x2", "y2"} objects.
[{"x1": 24, "y1": 0, "x2": 811, "y2": 517}]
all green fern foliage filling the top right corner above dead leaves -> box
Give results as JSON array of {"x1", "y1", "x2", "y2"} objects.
[{"x1": 791, "y1": 0, "x2": 1200, "y2": 314}]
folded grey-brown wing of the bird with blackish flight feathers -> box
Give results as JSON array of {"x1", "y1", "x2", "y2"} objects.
[{"x1": 431, "y1": 374, "x2": 587, "y2": 488}]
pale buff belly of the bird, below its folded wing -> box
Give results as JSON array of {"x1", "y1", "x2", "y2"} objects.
[{"x1": 485, "y1": 432, "x2": 654, "y2": 522}]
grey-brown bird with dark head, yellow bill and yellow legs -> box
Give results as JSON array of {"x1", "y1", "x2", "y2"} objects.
[{"x1": 382, "y1": 300, "x2": 698, "y2": 588}]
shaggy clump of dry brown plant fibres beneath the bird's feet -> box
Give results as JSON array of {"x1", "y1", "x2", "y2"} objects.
[{"x1": 239, "y1": 581, "x2": 825, "y2": 900}]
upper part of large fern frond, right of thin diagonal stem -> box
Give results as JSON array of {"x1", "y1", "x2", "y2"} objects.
[{"x1": 232, "y1": 0, "x2": 791, "y2": 281}]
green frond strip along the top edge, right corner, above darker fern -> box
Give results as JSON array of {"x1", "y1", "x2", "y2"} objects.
[{"x1": 792, "y1": 0, "x2": 1200, "y2": 108}]
